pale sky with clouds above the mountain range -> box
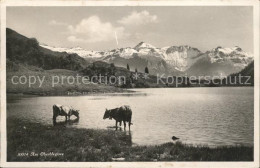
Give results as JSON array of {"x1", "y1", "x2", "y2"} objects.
[{"x1": 6, "y1": 6, "x2": 253, "y2": 53}]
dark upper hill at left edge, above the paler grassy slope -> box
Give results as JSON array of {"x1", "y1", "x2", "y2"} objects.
[{"x1": 6, "y1": 28, "x2": 88, "y2": 71}]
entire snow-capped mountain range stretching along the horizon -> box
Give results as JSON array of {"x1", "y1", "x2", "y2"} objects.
[{"x1": 41, "y1": 42, "x2": 253, "y2": 75}]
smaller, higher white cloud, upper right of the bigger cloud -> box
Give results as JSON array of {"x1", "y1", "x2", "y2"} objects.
[{"x1": 118, "y1": 10, "x2": 158, "y2": 26}]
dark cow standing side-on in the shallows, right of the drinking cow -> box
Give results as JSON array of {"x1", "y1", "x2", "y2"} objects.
[{"x1": 103, "y1": 106, "x2": 133, "y2": 131}]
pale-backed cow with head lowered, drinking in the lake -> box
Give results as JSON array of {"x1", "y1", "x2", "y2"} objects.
[{"x1": 52, "y1": 104, "x2": 79, "y2": 122}]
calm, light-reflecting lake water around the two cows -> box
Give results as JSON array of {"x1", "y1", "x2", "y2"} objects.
[{"x1": 7, "y1": 87, "x2": 254, "y2": 147}]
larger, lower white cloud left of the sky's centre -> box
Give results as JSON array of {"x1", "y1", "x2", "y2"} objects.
[{"x1": 67, "y1": 15, "x2": 125, "y2": 43}]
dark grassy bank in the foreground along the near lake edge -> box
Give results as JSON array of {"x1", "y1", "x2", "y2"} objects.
[{"x1": 7, "y1": 119, "x2": 253, "y2": 161}]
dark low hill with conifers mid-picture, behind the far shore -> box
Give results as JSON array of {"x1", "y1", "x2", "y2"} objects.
[{"x1": 81, "y1": 61, "x2": 193, "y2": 88}]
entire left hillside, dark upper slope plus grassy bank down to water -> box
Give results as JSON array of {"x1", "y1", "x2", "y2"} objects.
[{"x1": 6, "y1": 28, "x2": 123, "y2": 95}]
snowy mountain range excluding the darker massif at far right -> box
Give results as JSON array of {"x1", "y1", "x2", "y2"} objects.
[{"x1": 41, "y1": 42, "x2": 204, "y2": 75}]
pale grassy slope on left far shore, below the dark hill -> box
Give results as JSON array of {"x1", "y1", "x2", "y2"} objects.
[{"x1": 6, "y1": 69, "x2": 127, "y2": 96}]
